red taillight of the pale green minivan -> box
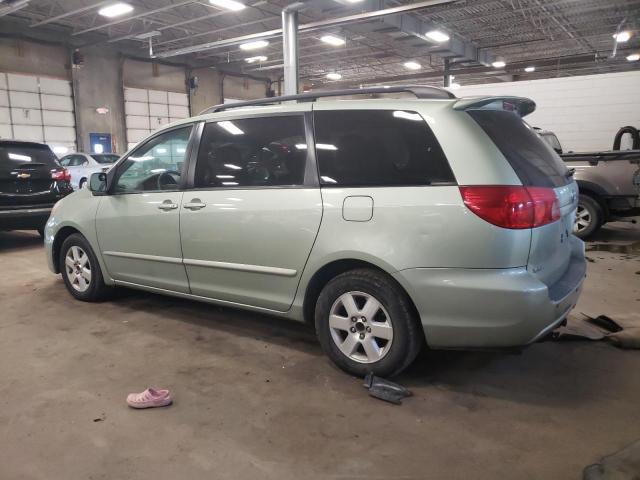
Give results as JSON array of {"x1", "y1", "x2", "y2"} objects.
[{"x1": 460, "y1": 185, "x2": 560, "y2": 228}]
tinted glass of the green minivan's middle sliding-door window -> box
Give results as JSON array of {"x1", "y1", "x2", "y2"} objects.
[{"x1": 195, "y1": 115, "x2": 307, "y2": 188}]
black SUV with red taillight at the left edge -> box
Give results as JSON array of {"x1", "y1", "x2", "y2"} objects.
[{"x1": 0, "y1": 140, "x2": 73, "y2": 235}]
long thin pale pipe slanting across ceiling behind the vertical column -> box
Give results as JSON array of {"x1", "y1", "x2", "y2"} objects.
[{"x1": 156, "y1": 0, "x2": 456, "y2": 58}]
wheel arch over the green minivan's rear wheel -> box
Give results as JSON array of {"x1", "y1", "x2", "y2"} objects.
[{"x1": 302, "y1": 258, "x2": 422, "y2": 328}]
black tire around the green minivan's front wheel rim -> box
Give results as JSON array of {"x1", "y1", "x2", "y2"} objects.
[{"x1": 58, "y1": 233, "x2": 111, "y2": 302}]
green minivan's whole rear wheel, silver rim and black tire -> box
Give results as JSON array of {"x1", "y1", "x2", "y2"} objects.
[{"x1": 315, "y1": 269, "x2": 424, "y2": 377}]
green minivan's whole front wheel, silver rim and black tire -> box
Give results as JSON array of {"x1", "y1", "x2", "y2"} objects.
[{"x1": 60, "y1": 233, "x2": 109, "y2": 302}]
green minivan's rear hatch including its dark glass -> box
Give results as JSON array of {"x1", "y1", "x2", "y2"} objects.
[{"x1": 466, "y1": 107, "x2": 578, "y2": 286}]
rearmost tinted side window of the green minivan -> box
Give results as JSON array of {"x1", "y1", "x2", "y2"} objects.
[{"x1": 314, "y1": 110, "x2": 455, "y2": 186}]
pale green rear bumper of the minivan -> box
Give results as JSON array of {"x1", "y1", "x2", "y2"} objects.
[{"x1": 394, "y1": 237, "x2": 586, "y2": 348}]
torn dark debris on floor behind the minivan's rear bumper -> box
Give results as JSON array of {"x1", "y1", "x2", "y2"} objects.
[{"x1": 553, "y1": 313, "x2": 640, "y2": 349}]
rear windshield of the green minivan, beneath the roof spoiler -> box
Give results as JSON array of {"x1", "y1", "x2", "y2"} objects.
[{"x1": 467, "y1": 110, "x2": 569, "y2": 188}]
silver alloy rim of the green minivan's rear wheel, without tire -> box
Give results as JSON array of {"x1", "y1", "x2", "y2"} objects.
[{"x1": 329, "y1": 292, "x2": 393, "y2": 363}]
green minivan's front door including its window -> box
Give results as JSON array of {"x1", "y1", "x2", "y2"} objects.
[{"x1": 96, "y1": 125, "x2": 191, "y2": 293}]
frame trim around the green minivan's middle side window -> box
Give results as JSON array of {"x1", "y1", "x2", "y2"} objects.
[{"x1": 185, "y1": 111, "x2": 320, "y2": 192}]
